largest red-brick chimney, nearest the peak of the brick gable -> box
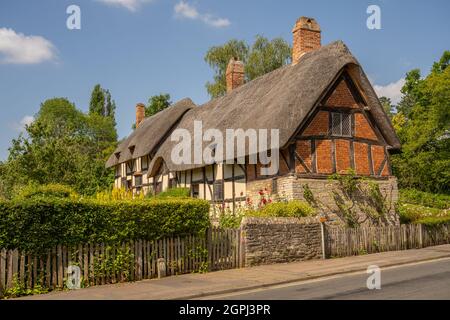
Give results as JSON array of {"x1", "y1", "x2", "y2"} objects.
[{"x1": 292, "y1": 17, "x2": 321, "y2": 65}]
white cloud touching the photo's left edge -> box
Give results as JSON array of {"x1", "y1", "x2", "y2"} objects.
[{"x1": 0, "y1": 28, "x2": 56, "y2": 64}]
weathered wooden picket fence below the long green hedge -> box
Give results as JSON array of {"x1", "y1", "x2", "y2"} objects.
[{"x1": 0, "y1": 228, "x2": 243, "y2": 297}]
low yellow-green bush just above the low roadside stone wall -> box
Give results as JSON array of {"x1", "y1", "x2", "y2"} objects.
[{"x1": 247, "y1": 200, "x2": 315, "y2": 218}]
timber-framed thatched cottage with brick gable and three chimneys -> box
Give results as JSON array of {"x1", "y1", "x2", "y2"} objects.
[{"x1": 107, "y1": 17, "x2": 400, "y2": 224}]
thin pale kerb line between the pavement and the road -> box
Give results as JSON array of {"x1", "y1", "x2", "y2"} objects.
[{"x1": 198, "y1": 257, "x2": 450, "y2": 300}]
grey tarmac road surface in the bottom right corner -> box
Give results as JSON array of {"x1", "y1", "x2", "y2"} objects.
[{"x1": 203, "y1": 259, "x2": 450, "y2": 300}]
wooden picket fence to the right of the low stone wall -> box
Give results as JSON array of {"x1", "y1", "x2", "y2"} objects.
[{"x1": 325, "y1": 224, "x2": 450, "y2": 257}]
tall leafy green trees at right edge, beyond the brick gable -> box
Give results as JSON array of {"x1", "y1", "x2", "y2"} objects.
[{"x1": 392, "y1": 51, "x2": 450, "y2": 194}]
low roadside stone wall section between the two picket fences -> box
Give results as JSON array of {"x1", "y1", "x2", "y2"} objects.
[{"x1": 241, "y1": 217, "x2": 322, "y2": 267}]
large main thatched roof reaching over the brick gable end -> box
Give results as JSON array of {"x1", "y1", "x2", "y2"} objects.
[{"x1": 108, "y1": 41, "x2": 400, "y2": 174}]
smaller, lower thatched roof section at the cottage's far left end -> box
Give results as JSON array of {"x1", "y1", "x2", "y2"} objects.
[{"x1": 106, "y1": 98, "x2": 195, "y2": 167}]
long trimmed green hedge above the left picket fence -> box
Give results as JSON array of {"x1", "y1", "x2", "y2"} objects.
[{"x1": 0, "y1": 198, "x2": 210, "y2": 253}]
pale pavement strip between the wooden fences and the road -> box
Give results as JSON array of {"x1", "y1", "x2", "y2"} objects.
[{"x1": 20, "y1": 245, "x2": 450, "y2": 300}]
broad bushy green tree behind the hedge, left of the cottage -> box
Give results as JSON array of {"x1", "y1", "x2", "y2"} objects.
[{"x1": 0, "y1": 98, "x2": 117, "y2": 198}]
